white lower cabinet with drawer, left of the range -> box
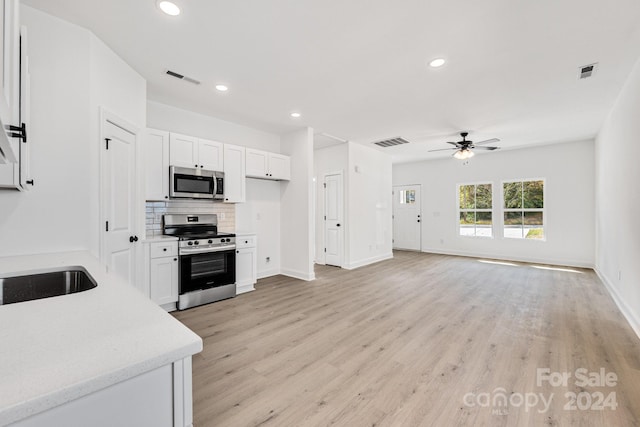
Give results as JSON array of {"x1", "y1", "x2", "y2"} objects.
[{"x1": 149, "y1": 241, "x2": 179, "y2": 311}]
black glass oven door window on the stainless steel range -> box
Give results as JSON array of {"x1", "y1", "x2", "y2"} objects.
[{"x1": 180, "y1": 250, "x2": 236, "y2": 294}]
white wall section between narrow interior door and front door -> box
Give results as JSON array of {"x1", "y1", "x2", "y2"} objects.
[{"x1": 345, "y1": 142, "x2": 393, "y2": 268}]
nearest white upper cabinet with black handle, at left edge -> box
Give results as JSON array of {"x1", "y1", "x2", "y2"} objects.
[{"x1": 0, "y1": 0, "x2": 20, "y2": 163}]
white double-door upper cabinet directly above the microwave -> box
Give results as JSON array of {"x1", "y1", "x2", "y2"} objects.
[{"x1": 169, "y1": 132, "x2": 224, "y2": 171}]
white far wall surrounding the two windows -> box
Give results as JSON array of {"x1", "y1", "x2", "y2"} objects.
[{"x1": 393, "y1": 141, "x2": 595, "y2": 266}]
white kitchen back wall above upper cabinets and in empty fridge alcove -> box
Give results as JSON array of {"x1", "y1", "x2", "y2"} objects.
[{"x1": 147, "y1": 101, "x2": 281, "y2": 277}]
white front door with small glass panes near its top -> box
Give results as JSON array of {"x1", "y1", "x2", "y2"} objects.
[{"x1": 393, "y1": 185, "x2": 422, "y2": 251}]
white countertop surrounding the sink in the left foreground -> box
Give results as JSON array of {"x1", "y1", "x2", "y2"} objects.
[{"x1": 0, "y1": 252, "x2": 202, "y2": 425}]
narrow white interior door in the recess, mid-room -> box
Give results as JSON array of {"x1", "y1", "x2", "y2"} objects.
[{"x1": 324, "y1": 172, "x2": 344, "y2": 267}]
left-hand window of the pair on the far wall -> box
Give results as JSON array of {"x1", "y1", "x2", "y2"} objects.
[{"x1": 458, "y1": 184, "x2": 493, "y2": 237}]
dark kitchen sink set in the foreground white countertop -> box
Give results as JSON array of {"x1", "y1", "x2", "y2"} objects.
[{"x1": 0, "y1": 267, "x2": 98, "y2": 305}]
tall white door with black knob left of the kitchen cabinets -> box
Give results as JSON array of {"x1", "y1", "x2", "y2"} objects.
[{"x1": 102, "y1": 119, "x2": 137, "y2": 286}]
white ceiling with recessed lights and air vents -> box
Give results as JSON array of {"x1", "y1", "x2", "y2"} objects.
[{"x1": 22, "y1": 0, "x2": 640, "y2": 162}]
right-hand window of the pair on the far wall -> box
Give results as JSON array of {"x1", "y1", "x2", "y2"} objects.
[{"x1": 502, "y1": 180, "x2": 544, "y2": 240}]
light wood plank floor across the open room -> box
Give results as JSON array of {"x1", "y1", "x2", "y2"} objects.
[{"x1": 176, "y1": 252, "x2": 640, "y2": 427}]
